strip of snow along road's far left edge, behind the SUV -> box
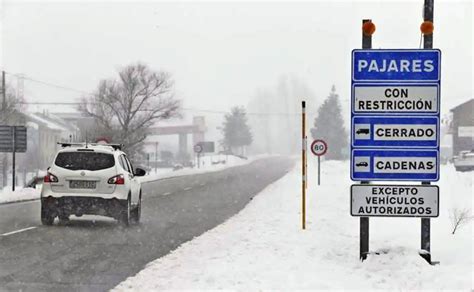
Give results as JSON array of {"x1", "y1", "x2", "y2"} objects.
[{"x1": 0, "y1": 155, "x2": 256, "y2": 204}]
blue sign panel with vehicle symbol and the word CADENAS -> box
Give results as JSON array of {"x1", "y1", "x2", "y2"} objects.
[{"x1": 351, "y1": 150, "x2": 439, "y2": 181}]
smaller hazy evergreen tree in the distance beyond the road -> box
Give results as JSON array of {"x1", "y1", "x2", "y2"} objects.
[{"x1": 222, "y1": 106, "x2": 253, "y2": 154}]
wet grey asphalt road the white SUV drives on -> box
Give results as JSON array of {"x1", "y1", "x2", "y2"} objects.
[{"x1": 0, "y1": 158, "x2": 293, "y2": 291}]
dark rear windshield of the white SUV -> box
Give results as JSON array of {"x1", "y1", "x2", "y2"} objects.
[{"x1": 54, "y1": 152, "x2": 115, "y2": 170}]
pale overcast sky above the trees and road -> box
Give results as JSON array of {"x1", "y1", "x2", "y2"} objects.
[{"x1": 1, "y1": 0, "x2": 473, "y2": 120}]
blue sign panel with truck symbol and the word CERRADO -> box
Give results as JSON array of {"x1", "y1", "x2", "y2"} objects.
[{"x1": 351, "y1": 116, "x2": 439, "y2": 148}]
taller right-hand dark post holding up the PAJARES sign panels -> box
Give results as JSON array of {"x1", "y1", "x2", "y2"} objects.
[{"x1": 420, "y1": 0, "x2": 434, "y2": 264}]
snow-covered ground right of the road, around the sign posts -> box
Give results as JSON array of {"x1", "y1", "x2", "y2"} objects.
[{"x1": 114, "y1": 161, "x2": 474, "y2": 291}]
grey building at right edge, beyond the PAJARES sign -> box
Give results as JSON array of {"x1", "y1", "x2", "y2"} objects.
[{"x1": 451, "y1": 99, "x2": 474, "y2": 155}]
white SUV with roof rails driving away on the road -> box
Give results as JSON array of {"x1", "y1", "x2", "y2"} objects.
[{"x1": 41, "y1": 143, "x2": 145, "y2": 226}]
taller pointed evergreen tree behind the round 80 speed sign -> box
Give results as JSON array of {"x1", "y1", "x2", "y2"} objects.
[{"x1": 311, "y1": 85, "x2": 348, "y2": 160}]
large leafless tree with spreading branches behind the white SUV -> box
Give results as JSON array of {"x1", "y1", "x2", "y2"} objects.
[{"x1": 79, "y1": 63, "x2": 181, "y2": 160}]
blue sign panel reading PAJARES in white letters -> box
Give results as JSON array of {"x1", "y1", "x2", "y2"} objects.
[{"x1": 352, "y1": 49, "x2": 441, "y2": 82}]
